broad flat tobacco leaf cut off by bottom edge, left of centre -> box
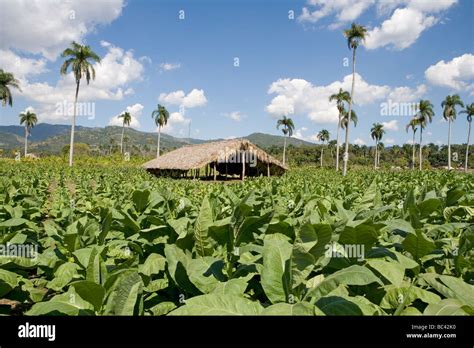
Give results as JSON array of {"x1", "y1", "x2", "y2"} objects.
[{"x1": 168, "y1": 294, "x2": 263, "y2": 315}]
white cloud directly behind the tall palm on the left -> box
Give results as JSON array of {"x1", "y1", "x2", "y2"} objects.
[{"x1": 19, "y1": 44, "x2": 144, "y2": 121}]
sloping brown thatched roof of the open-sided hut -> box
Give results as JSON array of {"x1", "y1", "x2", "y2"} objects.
[{"x1": 143, "y1": 139, "x2": 288, "y2": 170}]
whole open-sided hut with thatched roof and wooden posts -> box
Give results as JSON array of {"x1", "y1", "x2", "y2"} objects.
[{"x1": 143, "y1": 139, "x2": 288, "y2": 180}]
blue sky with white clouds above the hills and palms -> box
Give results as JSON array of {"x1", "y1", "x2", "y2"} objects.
[{"x1": 0, "y1": 0, "x2": 474, "y2": 145}]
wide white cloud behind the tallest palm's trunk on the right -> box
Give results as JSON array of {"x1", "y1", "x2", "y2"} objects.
[{"x1": 266, "y1": 74, "x2": 426, "y2": 123}]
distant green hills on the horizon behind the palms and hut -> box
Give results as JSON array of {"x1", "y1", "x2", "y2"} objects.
[{"x1": 0, "y1": 123, "x2": 313, "y2": 154}]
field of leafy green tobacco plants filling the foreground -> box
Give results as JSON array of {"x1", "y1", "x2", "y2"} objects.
[{"x1": 0, "y1": 162, "x2": 474, "y2": 315}]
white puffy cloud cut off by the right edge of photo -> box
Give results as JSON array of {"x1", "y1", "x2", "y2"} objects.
[{"x1": 425, "y1": 53, "x2": 474, "y2": 90}]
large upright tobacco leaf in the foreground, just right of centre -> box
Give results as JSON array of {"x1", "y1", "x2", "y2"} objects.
[{"x1": 261, "y1": 239, "x2": 293, "y2": 303}]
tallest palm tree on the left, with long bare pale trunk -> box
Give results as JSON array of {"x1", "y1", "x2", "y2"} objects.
[{"x1": 60, "y1": 41, "x2": 100, "y2": 167}]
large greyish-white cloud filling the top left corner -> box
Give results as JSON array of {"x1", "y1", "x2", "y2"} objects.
[{"x1": 0, "y1": 0, "x2": 124, "y2": 60}]
